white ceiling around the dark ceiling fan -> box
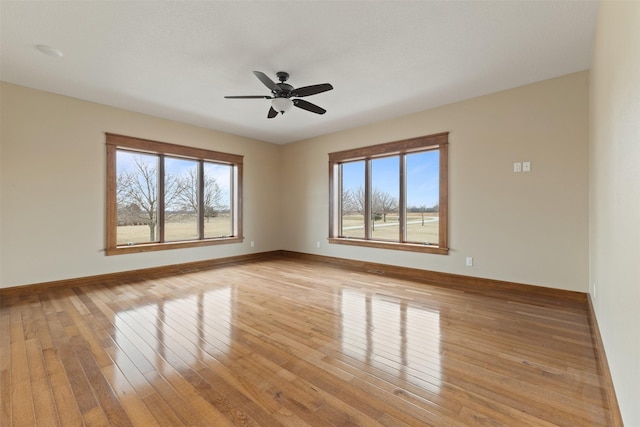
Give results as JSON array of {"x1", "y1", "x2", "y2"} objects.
[{"x1": 0, "y1": 0, "x2": 597, "y2": 144}]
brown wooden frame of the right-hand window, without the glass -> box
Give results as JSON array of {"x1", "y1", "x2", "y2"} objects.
[{"x1": 329, "y1": 132, "x2": 449, "y2": 255}]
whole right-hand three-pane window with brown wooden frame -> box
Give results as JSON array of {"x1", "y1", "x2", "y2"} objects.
[{"x1": 329, "y1": 132, "x2": 449, "y2": 254}]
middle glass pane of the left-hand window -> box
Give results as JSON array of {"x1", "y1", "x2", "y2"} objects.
[{"x1": 164, "y1": 157, "x2": 198, "y2": 241}]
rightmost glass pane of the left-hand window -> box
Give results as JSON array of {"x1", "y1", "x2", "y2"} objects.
[{"x1": 204, "y1": 162, "x2": 233, "y2": 238}]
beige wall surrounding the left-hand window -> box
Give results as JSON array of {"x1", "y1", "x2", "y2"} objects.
[{"x1": 0, "y1": 83, "x2": 282, "y2": 287}]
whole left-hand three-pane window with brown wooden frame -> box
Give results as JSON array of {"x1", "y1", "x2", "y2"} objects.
[{"x1": 106, "y1": 133, "x2": 243, "y2": 255}]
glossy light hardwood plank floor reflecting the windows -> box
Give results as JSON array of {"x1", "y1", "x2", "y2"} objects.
[{"x1": 0, "y1": 258, "x2": 610, "y2": 427}]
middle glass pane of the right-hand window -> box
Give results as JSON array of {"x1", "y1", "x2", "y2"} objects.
[{"x1": 371, "y1": 156, "x2": 400, "y2": 242}]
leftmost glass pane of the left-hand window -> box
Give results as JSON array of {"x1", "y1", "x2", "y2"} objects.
[{"x1": 116, "y1": 150, "x2": 158, "y2": 245}]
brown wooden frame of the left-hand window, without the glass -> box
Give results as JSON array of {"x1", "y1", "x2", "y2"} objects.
[{"x1": 105, "y1": 133, "x2": 244, "y2": 255}]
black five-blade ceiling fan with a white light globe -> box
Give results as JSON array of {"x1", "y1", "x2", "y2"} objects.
[{"x1": 225, "y1": 71, "x2": 333, "y2": 119}]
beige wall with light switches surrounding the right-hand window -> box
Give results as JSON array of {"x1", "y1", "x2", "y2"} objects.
[{"x1": 281, "y1": 72, "x2": 589, "y2": 292}]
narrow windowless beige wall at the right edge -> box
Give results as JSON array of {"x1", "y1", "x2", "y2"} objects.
[{"x1": 589, "y1": 1, "x2": 640, "y2": 426}]
